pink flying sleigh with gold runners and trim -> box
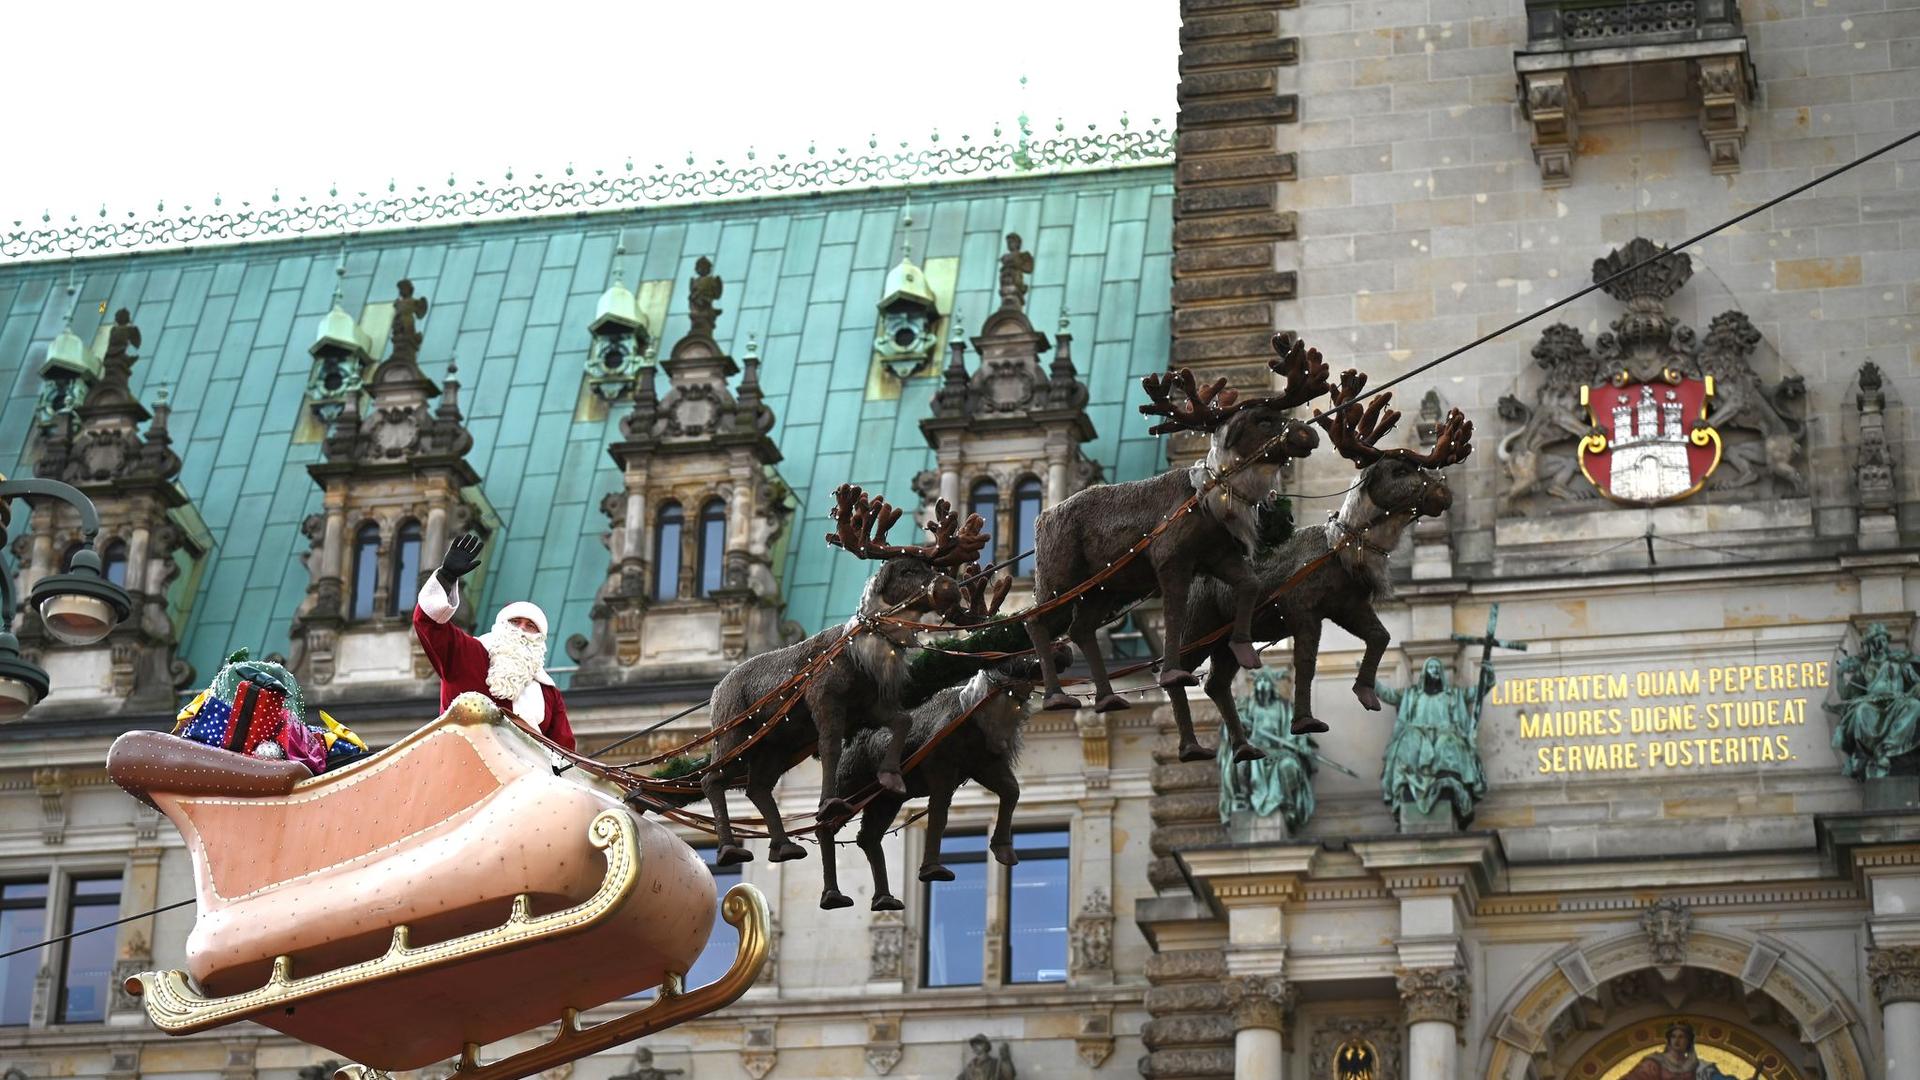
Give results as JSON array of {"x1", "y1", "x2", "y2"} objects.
[{"x1": 108, "y1": 694, "x2": 768, "y2": 1080}]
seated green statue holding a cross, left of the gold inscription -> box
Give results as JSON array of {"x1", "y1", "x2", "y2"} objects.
[{"x1": 1375, "y1": 603, "x2": 1526, "y2": 824}]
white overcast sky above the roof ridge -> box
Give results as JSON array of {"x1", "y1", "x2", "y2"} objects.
[{"x1": 0, "y1": 0, "x2": 1179, "y2": 229}]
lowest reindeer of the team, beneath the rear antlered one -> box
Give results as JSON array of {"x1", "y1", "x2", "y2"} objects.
[{"x1": 820, "y1": 657, "x2": 1039, "y2": 911}]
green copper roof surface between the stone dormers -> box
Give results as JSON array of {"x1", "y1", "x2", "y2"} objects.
[{"x1": 0, "y1": 167, "x2": 1173, "y2": 687}]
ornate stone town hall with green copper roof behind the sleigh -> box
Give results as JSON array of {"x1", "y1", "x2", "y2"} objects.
[{"x1": 0, "y1": 0, "x2": 1920, "y2": 1080}]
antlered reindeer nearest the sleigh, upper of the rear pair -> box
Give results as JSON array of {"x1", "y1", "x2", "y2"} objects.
[{"x1": 701, "y1": 484, "x2": 1004, "y2": 867}]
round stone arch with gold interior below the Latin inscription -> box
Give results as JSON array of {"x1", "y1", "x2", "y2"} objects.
[{"x1": 1478, "y1": 928, "x2": 1868, "y2": 1080}]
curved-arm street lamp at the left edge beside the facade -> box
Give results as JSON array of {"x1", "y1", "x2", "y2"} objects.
[{"x1": 0, "y1": 479, "x2": 132, "y2": 721}]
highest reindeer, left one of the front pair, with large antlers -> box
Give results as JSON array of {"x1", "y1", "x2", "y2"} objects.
[{"x1": 1027, "y1": 334, "x2": 1329, "y2": 761}]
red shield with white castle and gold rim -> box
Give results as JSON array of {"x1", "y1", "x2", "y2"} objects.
[{"x1": 1580, "y1": 369, "x2": 1720, "y2": 505}]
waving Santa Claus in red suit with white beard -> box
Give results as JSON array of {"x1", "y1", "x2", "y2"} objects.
[{"x1": 413, "y1": 534, "x2": 574, "y2": 749}]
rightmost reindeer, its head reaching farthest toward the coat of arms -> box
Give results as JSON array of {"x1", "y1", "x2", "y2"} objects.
[{"x1": 1171, "y1": 371, "x2": 1473, "y2": 734}]
